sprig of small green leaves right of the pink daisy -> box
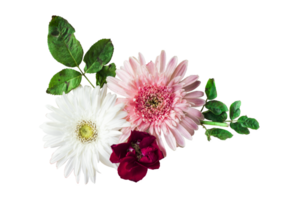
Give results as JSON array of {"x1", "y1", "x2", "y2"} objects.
[{"x1": 200, "y1": 78, "x2": 260, "y2": 141}]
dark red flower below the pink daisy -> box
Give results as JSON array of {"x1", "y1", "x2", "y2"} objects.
[{"x1": 110, "y1": 131, "x2": 164, "y2": 182}]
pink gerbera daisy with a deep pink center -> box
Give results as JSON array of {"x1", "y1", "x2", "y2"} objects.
[{"x1": 106, "y1": 49, "x2": 205, "y2": 157}]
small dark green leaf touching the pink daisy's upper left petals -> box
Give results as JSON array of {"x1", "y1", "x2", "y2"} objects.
[{"x1": 94, "y1": 62, "x2": 118, "y2": 88}]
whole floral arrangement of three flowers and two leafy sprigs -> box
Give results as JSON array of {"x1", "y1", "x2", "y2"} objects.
[{"x1": 38, "y1": 15, "x2": 262, "y2": 185}]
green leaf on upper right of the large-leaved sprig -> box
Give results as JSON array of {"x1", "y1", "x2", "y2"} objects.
[{"x1": 83, "y1": 38, "x2": 116, "y2": 74}]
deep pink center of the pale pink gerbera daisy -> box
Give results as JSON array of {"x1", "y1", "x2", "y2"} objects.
[{"x1": 133, "y1": 85, "x2": 175, "y2": 122}]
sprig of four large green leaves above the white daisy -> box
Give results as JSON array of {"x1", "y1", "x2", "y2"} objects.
[{"x1": 44, "y1": 15, "x2": 117, "y2": 96}]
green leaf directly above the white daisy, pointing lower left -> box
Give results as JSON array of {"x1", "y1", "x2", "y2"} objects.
[{"x1": 44, "y1": 68, "x2": 83, "y2": 96}]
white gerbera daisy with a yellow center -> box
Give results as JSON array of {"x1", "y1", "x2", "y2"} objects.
[{"x1": 38, "y1": 84, "x2": 130, "y2": 185}]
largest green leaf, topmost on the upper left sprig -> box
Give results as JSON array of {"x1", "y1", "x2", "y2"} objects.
[{"x1": 46, "y1": 16, "x2": 85, "y2": 67}]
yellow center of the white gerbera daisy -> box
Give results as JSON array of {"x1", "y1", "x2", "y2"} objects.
[{"x1": 76, "y1": 121, "x2": 97, "y2": 142}]
